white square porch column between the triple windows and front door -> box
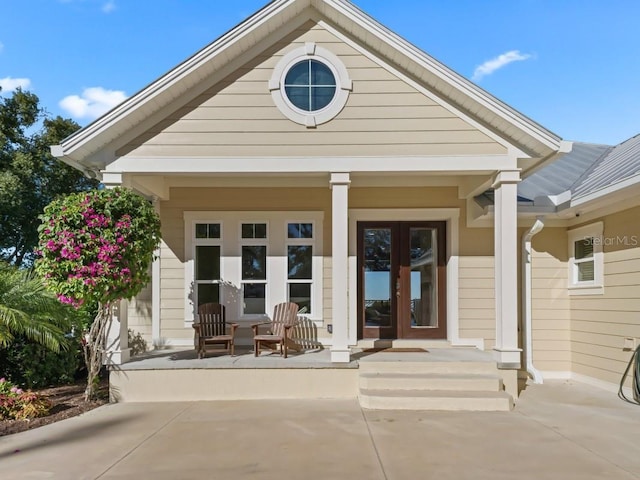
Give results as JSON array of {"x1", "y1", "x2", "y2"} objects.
[{"x1": 330, "y1": 173, "x2": 351, "y2": 363}]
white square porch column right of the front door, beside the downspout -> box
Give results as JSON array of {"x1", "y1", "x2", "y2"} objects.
[{"x1": 493, "y1": 170, "x2": 521, "y2": 369}]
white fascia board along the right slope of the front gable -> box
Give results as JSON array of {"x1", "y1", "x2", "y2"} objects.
[{"x1": 322, "y1": 0, "x2": 563, "y2": 151}]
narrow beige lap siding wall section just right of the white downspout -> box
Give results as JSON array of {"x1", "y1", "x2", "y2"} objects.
[{"x1": 520, "y1": 228, "x2": 571, "y2": 372}]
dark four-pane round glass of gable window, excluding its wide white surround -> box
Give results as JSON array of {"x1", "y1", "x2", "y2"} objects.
[{"x1": 284, "y1": 59, "x2": 337, "y2": 112}]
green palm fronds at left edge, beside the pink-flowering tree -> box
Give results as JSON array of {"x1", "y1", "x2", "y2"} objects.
[{"x1": 0, "y1": 262, "x2": 74, "y2": 352}]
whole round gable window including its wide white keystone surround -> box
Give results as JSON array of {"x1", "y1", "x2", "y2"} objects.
[{"x1": 269, "y1": 42, "x2": 353, "y2": 128}]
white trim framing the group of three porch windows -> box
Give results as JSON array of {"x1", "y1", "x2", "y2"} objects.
[{"x1": 183, "y1": 211, "x2": 324, "y2": 328}]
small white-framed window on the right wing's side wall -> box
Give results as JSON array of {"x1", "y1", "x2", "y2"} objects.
[{"x1": 568, "y1": 222, "x2": 604, "y2": 295}]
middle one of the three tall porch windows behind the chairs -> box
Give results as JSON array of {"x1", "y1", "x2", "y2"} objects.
[{"x1": 240, "y1": 221, "x2": 268, "y2": 317}]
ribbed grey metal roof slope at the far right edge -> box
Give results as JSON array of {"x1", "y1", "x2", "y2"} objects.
[{"x1": 571, "y1": 134, "x2": 640, "y2": 199}]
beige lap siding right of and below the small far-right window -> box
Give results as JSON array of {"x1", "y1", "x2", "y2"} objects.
[{"x1": 571, "y1": 208, "x2": 640, "y2": 386}]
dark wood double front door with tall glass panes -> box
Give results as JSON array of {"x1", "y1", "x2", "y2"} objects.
[{"x1": 358, "y1": 221, "x2": 447, "y2": 339}]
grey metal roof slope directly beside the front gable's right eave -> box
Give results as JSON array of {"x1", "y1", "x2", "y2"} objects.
[{"x1": 518, "y1": 142, "x2": 613, "y2": 200}]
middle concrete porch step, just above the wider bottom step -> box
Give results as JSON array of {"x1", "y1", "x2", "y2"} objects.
[{"x1": 359, "y1": 372, "x2": 502, "y2": 392}]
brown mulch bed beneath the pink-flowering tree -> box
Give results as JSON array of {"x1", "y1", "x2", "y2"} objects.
[{"x1": 0, "y1": 380, "x2": 109, "y2": 437}]
